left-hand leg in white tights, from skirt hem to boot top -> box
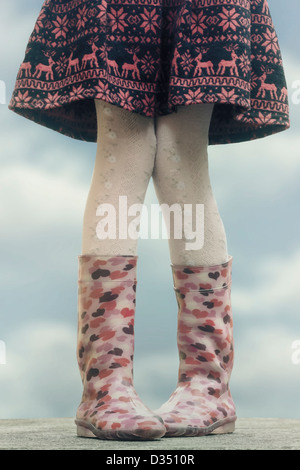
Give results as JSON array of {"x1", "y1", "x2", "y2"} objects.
[{"x1": 82, "y1": 100, "x2": 156, "y2": 255}]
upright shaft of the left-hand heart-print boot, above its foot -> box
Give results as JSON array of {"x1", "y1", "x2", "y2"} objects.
[{"x1": 77, "y1": 255, "x2": 137, "y2": 393}]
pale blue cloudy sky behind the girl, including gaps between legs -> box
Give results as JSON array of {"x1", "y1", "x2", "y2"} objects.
[{"x1": 0, "y1": 0, "x2": 300, "y2": 419}]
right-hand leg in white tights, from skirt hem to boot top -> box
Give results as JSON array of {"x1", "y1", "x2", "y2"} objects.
[{"x1": 153, "y1": 104, "x2": 228, "y2": 265}]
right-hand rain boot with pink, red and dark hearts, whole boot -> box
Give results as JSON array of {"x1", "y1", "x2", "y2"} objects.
[{"x1": 156, "y1": 257, "x2": 236, "y2": 437}]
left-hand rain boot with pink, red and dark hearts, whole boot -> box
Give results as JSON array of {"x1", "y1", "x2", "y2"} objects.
[{"x1": 75, "y1": 255, "x2": 165, "y2": 439}]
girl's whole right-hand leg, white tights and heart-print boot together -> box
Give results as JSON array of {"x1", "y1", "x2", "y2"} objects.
[{"x1": 153, "y1": 104, "x2": 236, "y2": 437}]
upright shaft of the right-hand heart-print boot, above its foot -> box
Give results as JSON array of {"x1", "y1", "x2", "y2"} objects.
[{"x1": 171, "y1": 257, "x2": 234, "y2": 395}]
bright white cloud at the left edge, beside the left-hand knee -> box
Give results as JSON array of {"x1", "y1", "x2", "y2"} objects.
[{"x1": 0, "y1": 165, "x2": 86, "y2": 240}]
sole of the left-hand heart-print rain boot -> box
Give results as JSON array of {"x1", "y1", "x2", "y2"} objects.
[{"x1": 75, "y1": 420, "x2": 166, "y2": 441}]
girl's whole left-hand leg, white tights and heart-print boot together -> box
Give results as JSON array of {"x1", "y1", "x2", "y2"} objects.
[{"x1": 76, "y1": 101, "x2": 165, "y2": 439}]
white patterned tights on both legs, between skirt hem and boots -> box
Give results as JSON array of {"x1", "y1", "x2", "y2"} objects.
[{"x1": 82, "y1": 100, "x2": 228, "y2": 266}]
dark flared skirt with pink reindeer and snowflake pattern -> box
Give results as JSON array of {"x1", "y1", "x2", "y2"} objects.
[{"x1": 9, "y1": 0, "x2": 290, "y2": 144}]
